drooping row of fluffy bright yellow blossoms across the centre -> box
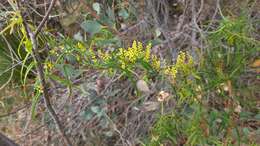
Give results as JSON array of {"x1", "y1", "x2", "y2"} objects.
[{"x1": 87, "y1": 41, "x2": 193, "y2": 80}]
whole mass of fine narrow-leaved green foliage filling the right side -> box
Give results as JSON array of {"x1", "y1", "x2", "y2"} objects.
[{"x1": 147, "y1": 13, "x2": 259, "y2": 145}]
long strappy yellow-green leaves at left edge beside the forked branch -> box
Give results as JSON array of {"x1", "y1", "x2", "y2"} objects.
[{"x1": 0, "y1": 1, "x2": 53, "y2": 115}]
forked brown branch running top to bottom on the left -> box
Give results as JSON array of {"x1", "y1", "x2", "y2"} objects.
[{"x1": 17, "y1": 0, "x2": 72, "y2": 146}]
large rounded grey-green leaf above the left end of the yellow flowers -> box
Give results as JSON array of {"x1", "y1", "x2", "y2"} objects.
[{"x1": 80, "y1": 20, "x2": 101, "y2": 35}]
